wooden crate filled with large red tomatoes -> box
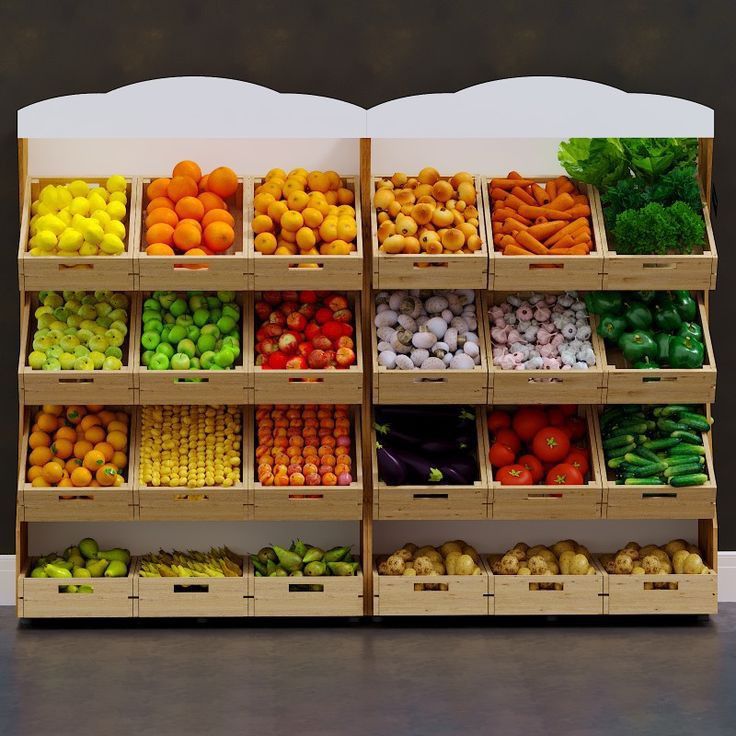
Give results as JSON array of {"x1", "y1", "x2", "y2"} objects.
[{"x1": 486, "y1": 405, "x2": 603, "y2": 519}]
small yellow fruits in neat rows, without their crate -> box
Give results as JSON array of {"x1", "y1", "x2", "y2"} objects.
[{"x1": 139, "y1": 405, "x2": 242, "y2": 488}]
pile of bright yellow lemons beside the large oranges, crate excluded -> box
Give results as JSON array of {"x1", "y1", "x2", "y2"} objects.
[{"x1": 28, "y1": 174, "x2": 128, "y2": 256}]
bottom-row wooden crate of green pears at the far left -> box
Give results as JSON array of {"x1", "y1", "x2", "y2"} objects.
[{"x1": 17, "y1": 537, "x2": 134, "y2": 618}]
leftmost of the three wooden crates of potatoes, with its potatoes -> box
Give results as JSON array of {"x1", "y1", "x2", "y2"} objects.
[{"x1": 373, "y1": 539, "x2": 493, "y2": 616}]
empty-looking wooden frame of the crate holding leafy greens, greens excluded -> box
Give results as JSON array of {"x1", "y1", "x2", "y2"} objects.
[{"x1": 595, "y1": 185, "x2": 718, "y2": 291}]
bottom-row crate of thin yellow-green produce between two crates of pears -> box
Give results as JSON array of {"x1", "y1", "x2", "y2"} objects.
[{"x1": 133, "y1": 547, "x2": 252, "y2": 618}]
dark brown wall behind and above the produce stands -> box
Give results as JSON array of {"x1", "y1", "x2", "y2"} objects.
[{"x1": 0, "y1": 0, "x2": 736, "y2": 553}]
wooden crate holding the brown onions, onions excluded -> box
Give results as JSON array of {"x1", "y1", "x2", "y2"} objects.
[{"x1": 371, "y1": 175, "x2": 489, "y2": 289}]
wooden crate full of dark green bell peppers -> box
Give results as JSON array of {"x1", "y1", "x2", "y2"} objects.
[{"x1": 585, "y1": 290, "x2": 716, "y2": 404}]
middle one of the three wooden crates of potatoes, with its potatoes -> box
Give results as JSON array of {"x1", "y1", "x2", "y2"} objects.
[{"x1": 488, "y1": 539, "x2": 606, "y2": 616}]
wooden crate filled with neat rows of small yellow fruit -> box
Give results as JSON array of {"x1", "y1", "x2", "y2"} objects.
[{"x1": 134, "y1": 404, "x2": 252, "y2": 521}]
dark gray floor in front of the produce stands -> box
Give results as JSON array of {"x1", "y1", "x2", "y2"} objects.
[{"x1": 0, "y1": 604, "x2": 736, "y2": 736}]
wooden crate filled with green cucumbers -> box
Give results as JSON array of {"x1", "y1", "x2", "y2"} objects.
[{"x1": 595, "y1": 404, "x2": 716, "y2": 519}]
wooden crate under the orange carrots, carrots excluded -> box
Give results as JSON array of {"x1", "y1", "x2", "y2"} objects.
[{"x1": 482, "y1": 176, "x2": 604, "y2": 291}]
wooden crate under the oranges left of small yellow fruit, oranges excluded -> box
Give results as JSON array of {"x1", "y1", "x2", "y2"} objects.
[{"x1": 18, "y1": 406, "x2": 135, "y2": 521}]
